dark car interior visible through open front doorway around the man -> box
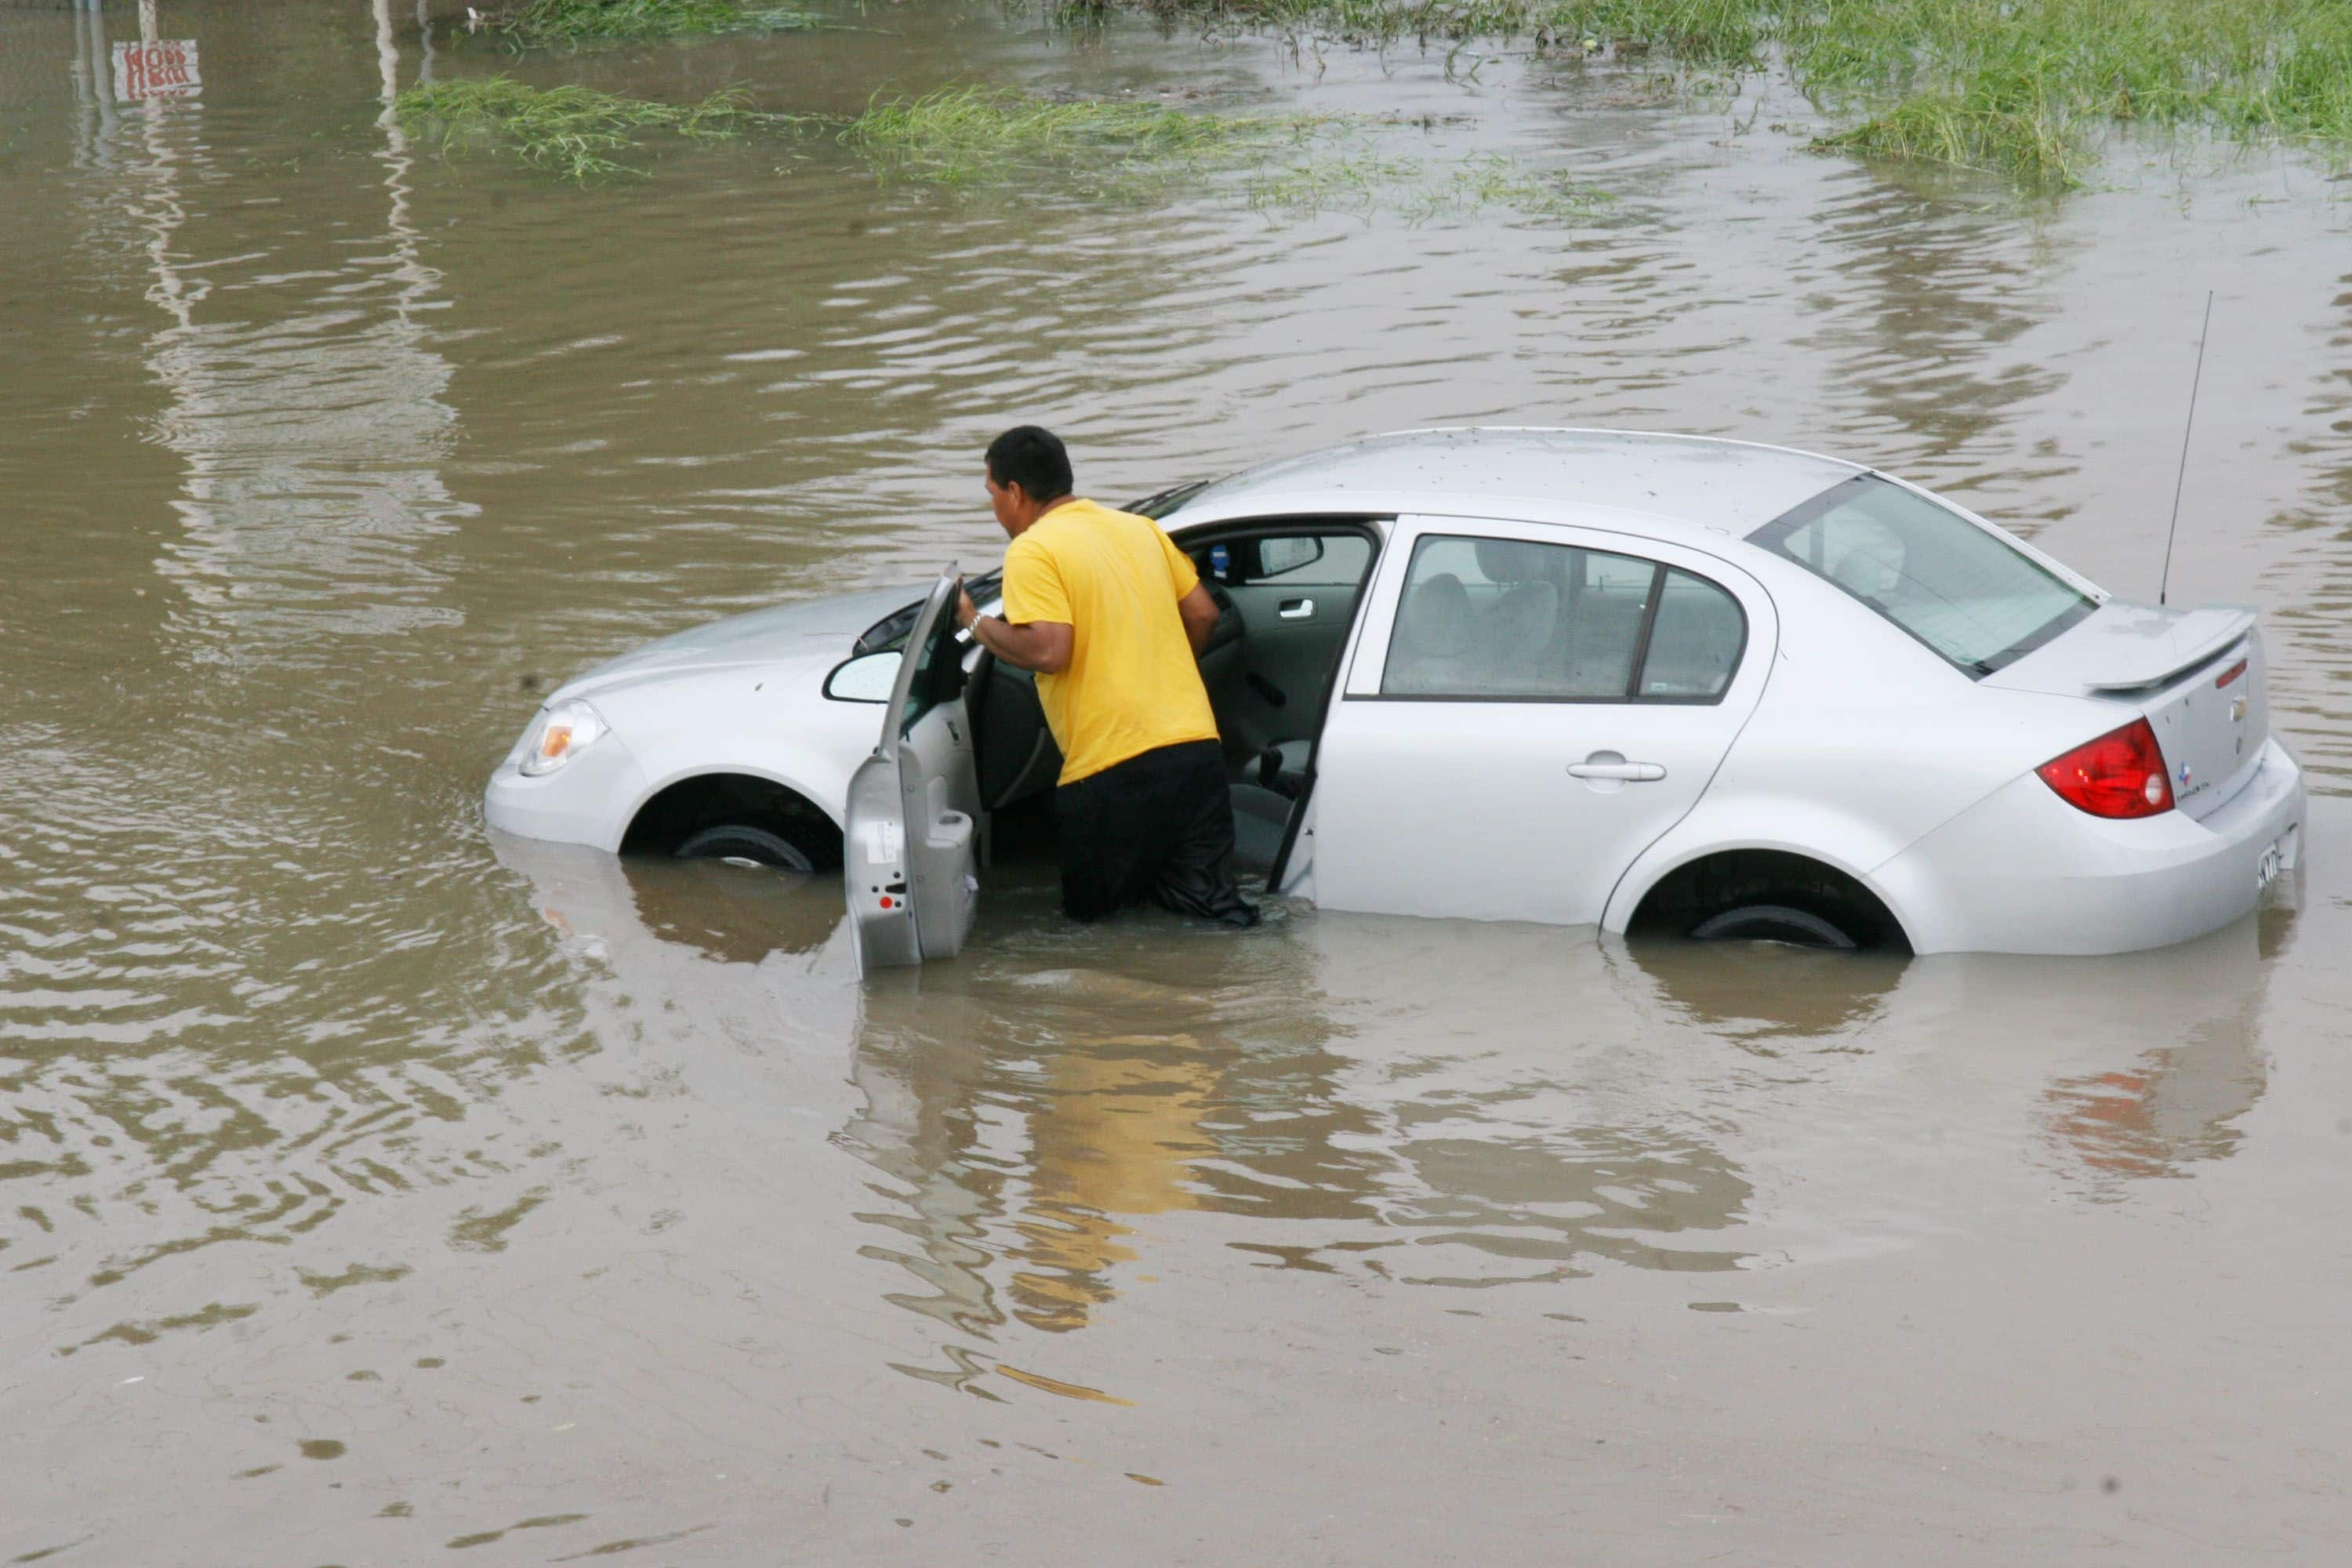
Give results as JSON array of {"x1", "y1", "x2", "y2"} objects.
[{"x1": 964, "y1": 517, "x2": 1376, "y2": 872}]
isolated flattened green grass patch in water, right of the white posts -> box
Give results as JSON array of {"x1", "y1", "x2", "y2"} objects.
[{"x1": 393, "y1": 75, "x2": 802, "y2": 181}]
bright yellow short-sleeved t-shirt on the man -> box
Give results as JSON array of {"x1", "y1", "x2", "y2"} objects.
[{"x1": 1004, "y1": 501, "x2": 1216, "y2": 783}]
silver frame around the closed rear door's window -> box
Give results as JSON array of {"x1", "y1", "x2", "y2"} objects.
[{"x1": 1324, "y1": 513, "x2": 1776, "y2": 724}]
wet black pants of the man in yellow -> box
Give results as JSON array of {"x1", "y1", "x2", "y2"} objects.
[{"x1": 1054, "y1": 741, "x2": 1258, "y2": 926}]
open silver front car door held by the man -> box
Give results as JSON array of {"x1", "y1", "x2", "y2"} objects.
[{"x1": 842, "y1": 567, "x2": 981, "y2": 975}]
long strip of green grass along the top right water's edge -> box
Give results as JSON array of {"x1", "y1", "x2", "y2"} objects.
[{"x1": 1091, "y1": 0, "x2": 2352, "y2": 186}]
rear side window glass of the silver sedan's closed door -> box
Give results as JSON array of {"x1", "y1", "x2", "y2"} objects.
[{"x1": 1381, "y1": 534, "x2": 1748, "y2": 703}]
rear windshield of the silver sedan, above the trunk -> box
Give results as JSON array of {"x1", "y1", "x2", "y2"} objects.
[{"x1": 1748, "y1": 475, "x2": 2096, "y2": 677}]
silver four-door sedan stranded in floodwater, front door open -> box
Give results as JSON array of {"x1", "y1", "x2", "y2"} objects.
[{"x1": 487, "y1": 430, "x2": 2303, "y2": 966}]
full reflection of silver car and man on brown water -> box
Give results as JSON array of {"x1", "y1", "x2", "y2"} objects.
[{"x1": 501, "y1": 841, "x2": 2293, "y2": 1399}]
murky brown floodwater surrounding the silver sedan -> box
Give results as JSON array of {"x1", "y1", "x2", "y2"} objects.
[{"x1": 0, "y1": 0, "x2": 2352, "y2": 1566}]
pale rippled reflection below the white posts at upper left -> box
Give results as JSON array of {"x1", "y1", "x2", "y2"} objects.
[{"x1": 136, "y1": 0, "x2": 473, "y2": 648}]
